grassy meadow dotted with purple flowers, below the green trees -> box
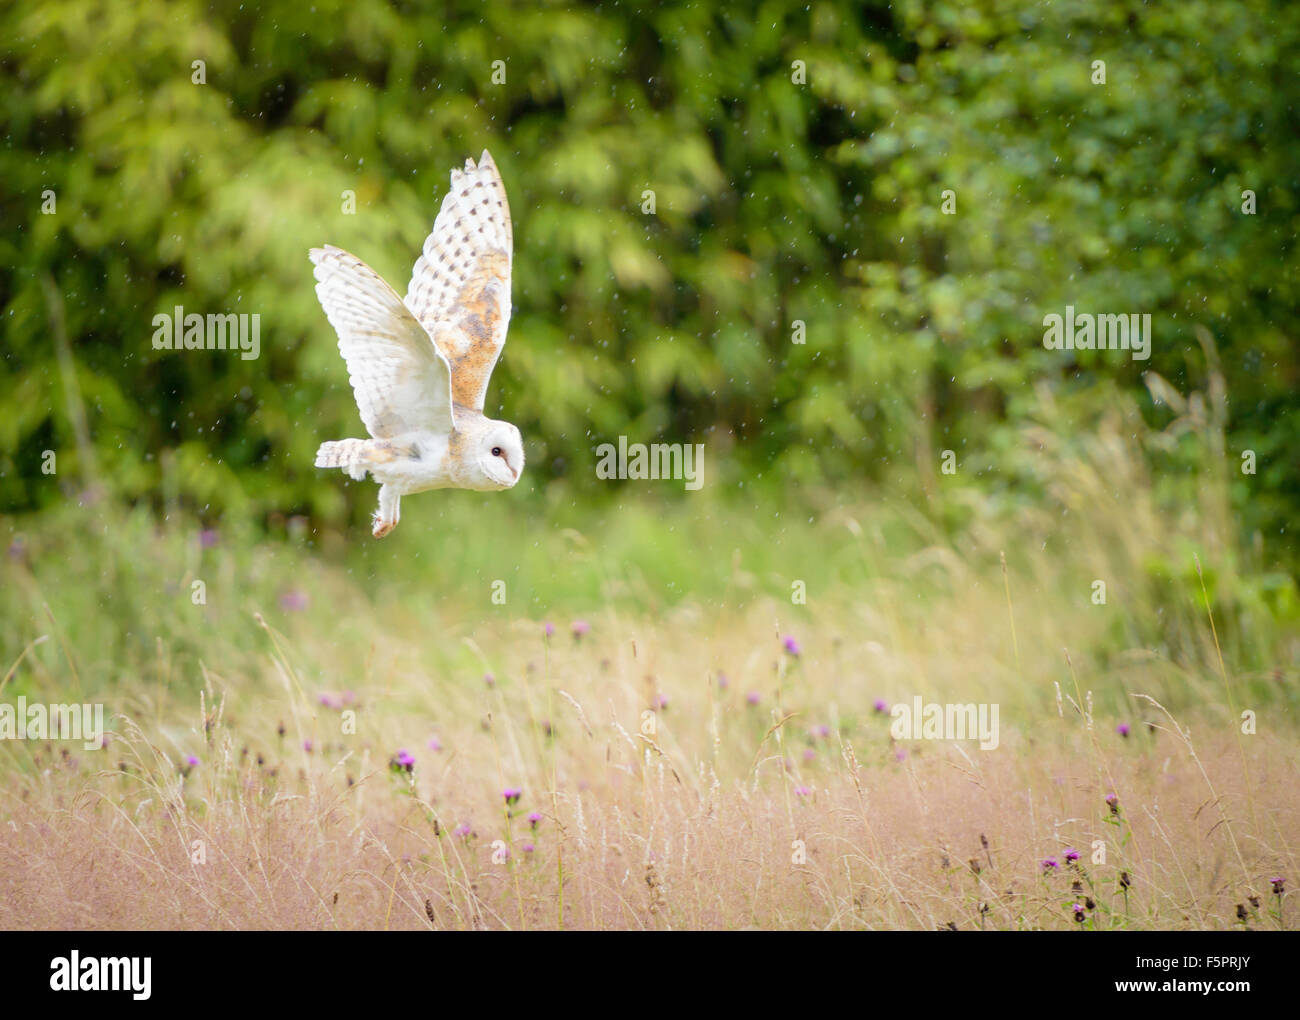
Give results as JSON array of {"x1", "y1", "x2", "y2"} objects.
[{"x1": 0, "y1": 410, "x2": 1300, "y2": 930}]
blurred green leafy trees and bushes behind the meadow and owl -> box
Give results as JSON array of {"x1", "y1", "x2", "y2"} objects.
[{"x1": 0, "y1": 0, "x2": 1300, "y2": 556}]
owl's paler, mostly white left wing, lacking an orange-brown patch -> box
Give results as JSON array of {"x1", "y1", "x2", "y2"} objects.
[{"x1": 311, "y1": 244, "x2": 455, "y2": 439}]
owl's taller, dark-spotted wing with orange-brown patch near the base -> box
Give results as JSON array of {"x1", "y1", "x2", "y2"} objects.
[{"x1": 406, "y1": 149, "x2": 515, "y2": 411}]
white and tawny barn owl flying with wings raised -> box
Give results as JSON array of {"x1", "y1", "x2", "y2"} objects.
[{"x1": 311, "y1": 149, "x2": 524, "y2": 538}]
